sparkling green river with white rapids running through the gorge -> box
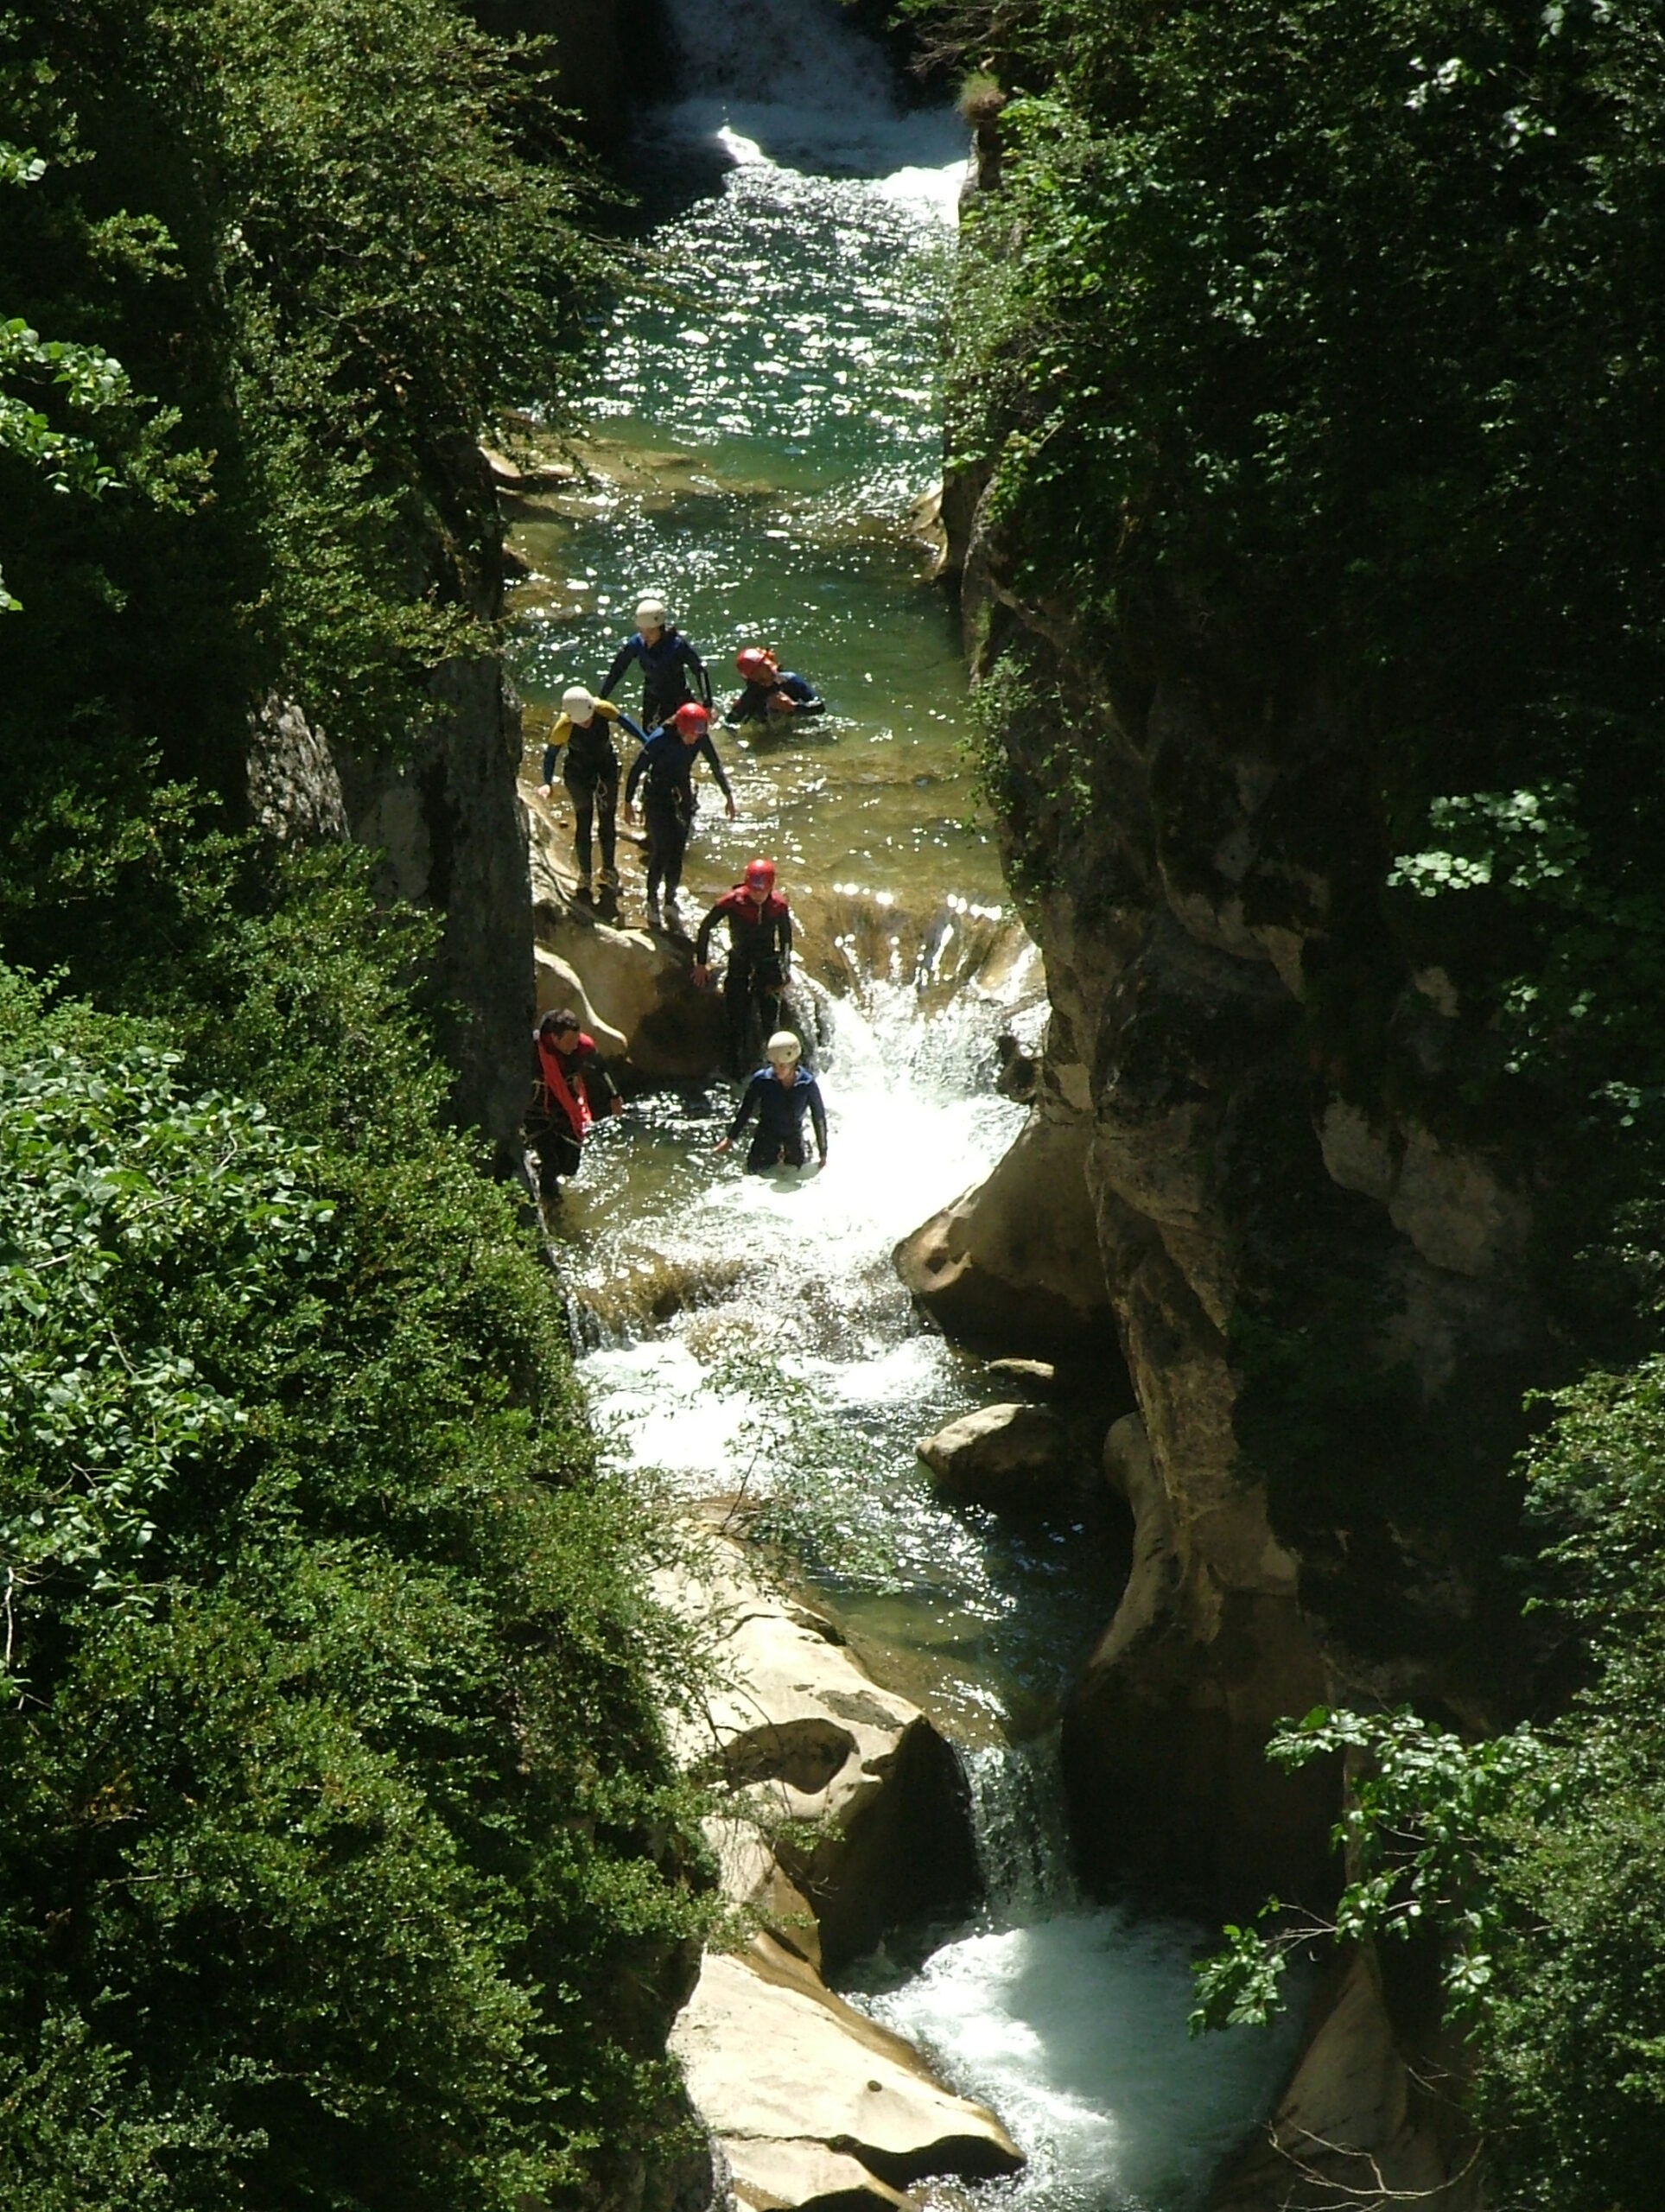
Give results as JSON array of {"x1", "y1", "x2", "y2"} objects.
[{"x1": 513, "y1": 0, "x2": 1287, "y2": 2212}]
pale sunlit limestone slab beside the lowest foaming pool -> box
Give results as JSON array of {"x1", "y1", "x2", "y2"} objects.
[{"x1": 670, "y1": 1938, "x2": 1024, "y2": 2205}]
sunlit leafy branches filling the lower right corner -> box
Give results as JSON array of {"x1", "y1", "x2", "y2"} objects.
[{"x1": 1194, "y1": 1358, "x2": 1665, "y2": 2212}]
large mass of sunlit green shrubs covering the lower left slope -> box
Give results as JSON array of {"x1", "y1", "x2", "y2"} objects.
[{"x1": 0, "y1": 925, "x2": 699, "y2": 2212}]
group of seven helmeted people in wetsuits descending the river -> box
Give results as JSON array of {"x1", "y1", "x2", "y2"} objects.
[{"x1": 526, "y1": 597, "x2": 827, "y2": 1197}]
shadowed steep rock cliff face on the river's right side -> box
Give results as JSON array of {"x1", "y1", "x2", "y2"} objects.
[{"x1": 946, "y1": 485, "x2": 1546, "y2": 1907}]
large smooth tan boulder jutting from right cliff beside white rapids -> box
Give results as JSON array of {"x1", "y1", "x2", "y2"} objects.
[{"x1": 895, "y1": 1115, "x2": 1119, "y2": 1363}]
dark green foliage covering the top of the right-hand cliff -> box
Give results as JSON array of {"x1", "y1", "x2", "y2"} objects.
[{"x1": 933, "y1": 0, "x2": 1665, "y2": 1159}]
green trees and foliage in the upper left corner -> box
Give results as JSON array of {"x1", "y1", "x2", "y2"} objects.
[{"x1": 0, "y1": 0, "x2": 604, "y2": 984}]
